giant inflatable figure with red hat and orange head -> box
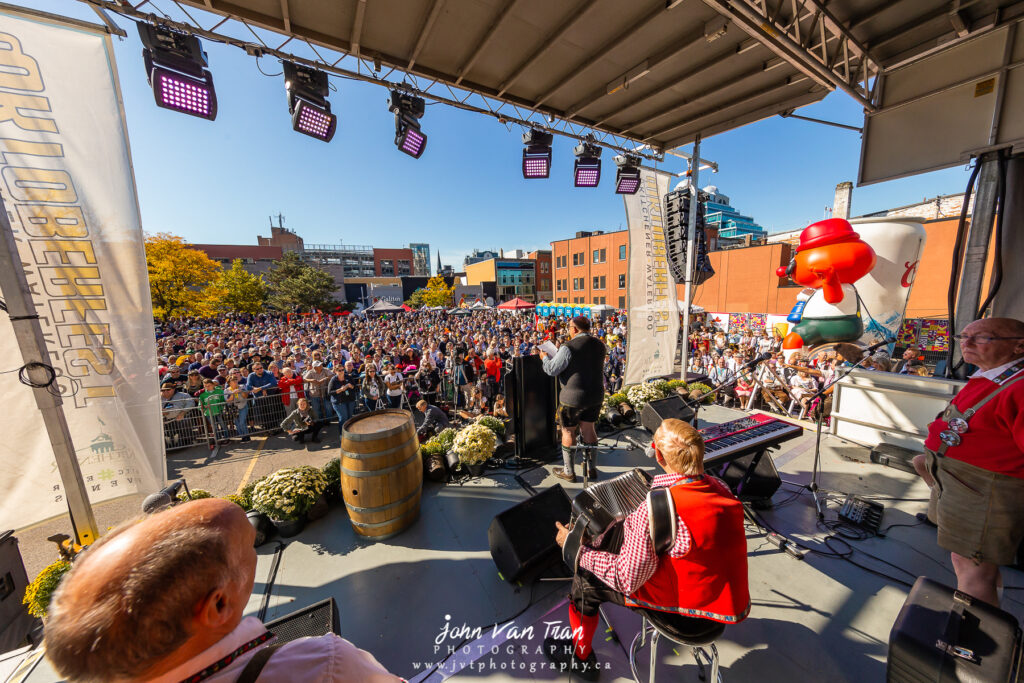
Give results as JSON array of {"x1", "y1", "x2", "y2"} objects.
[{"x1": 776, "y1": 218, "x2": 876, "y2": 359}]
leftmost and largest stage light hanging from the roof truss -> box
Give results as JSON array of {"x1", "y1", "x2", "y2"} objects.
[{"x1": 137, "y1": 23, "x2": 217, "y2": 121}]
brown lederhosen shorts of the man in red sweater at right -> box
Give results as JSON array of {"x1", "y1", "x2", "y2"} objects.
[{"x1": 925, "y1": 451, "x2": 1024, "y2": 564}]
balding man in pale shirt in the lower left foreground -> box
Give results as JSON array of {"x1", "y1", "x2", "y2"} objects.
[{"x1": 46, "y1": 499, "x2": 400, "y2": 683}]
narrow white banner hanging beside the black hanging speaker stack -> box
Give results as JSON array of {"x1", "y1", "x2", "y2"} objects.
[{"x1": 623, "y1": 169, "x2": 679, "y2": 384}]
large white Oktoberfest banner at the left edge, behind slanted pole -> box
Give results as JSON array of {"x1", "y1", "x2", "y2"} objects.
[{"x1": 0, "y1": 9, "x2": 166, "y2": 528}]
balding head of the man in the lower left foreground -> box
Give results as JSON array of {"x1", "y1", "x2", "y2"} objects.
[{"x1": 46, "y1": 499, "x2": 255, "y2": 681}]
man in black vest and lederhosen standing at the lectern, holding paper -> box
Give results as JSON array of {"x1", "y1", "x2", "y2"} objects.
[{"x1": 541, "y1": 315, "x2": 606, "y2": 481}]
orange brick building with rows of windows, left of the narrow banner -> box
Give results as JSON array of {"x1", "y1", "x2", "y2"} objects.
[{"x1": 551, "y1": 230, "x2": 629, "y2": 308}]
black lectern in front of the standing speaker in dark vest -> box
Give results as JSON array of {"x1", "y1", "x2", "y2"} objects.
[{"x1": 506, "y1": 355, "x2": 558, "y2": 461}]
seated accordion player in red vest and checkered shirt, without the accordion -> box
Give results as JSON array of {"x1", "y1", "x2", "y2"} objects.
[{"x1": 544, "y1": 418, "x2": 751, "y2": 681}]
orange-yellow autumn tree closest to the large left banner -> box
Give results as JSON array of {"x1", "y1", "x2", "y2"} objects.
[{"x1": 145, "y1": 232, "x2": 221, "y2": 321}]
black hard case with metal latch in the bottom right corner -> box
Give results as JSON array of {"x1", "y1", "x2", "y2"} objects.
[{"x1": 886, "y1": 577, "x2": 1021, "y2": 683}]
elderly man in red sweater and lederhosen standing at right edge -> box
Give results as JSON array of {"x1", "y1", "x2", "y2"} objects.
[{"x1": 914, "y1": 317, "x2": 1024, "y2": 606}]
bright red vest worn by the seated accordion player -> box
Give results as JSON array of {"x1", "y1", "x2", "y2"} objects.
[{"x1": 626, "y1": 477, "x2": 751, "y2": 624}]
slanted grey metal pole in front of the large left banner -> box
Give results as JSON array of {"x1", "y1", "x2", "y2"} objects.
[{"x1": 0, "y1": 196, "x2": 99, "y2": 546}]
